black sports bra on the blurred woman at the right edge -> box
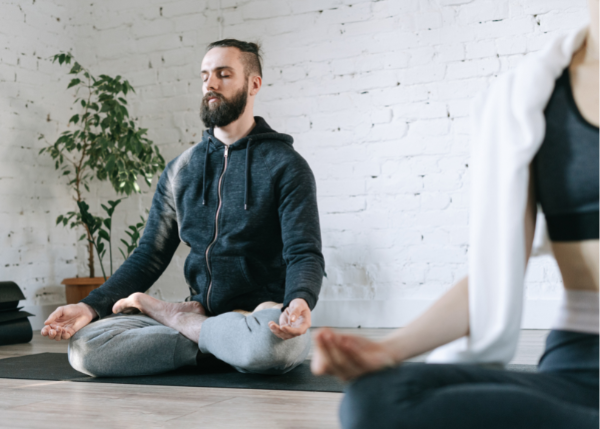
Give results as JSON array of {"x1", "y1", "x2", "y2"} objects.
[{"x1": 533, "y1": 67, "x2": 599, "y2": 241}]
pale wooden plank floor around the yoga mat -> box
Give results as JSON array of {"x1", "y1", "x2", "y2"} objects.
[{"x1": 0, "y1": 329, "x2": 548, "y2": 429}]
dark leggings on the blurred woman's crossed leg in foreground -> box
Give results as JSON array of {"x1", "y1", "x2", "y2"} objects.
[{"x1": 340, "y1": 331, "x2": 598, "y2": 429}]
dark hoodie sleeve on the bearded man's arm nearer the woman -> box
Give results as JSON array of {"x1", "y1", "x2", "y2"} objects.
[{"x1": 279, "y1": 157, "x2": 325, "y2": 310}]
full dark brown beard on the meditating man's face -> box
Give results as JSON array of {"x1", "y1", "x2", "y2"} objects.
[{"x1": 200, "y1": 82, "x2": 248, "y2": 128}]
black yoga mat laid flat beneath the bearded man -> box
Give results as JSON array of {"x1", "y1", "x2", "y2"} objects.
[{"x1": 0, "y1": 353, "x2": 536, "y2": 392}]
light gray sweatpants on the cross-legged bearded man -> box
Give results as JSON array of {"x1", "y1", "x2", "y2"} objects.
[{"x1": 69, "y1": 309, "x2": 311, "y2": 377}]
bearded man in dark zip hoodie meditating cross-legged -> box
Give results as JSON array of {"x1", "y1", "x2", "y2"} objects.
[{"x1": 42, "y1": 39, "x2": 324, "y2": 376}]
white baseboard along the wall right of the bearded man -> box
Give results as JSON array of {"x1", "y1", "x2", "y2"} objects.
[{"x1": 312, "y1": 299, "x2": 560, "y2": 329}]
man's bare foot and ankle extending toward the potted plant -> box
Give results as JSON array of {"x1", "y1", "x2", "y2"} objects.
[{"x1": 113, "y1": 293, "x2": 208, "y2": 343}]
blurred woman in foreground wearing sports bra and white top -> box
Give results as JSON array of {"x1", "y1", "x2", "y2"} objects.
[{"x1": 312, "y1": 0, "x2": 599, "y2": 429}]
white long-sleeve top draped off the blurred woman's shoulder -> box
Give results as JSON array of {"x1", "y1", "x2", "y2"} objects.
[{"x1": 428, "y1": 27, "x2": 587, "y2": 364}]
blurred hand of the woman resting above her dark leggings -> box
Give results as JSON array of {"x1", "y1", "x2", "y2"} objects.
[{"x1": 311, "y1": 328, "x2": 396, "y2": 381}]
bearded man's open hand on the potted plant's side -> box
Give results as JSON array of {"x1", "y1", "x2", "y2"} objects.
[{"x1": 42, "y1": 302, "x2": 96, "y2": 341}]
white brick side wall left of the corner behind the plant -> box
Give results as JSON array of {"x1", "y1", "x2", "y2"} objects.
[{"x1": 0, "y1": 1, "x2": 77, "y2": 326}]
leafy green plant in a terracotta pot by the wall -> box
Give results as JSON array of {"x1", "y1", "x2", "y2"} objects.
[{"x1": 40, "y1": 53, "x2": 165, "y2": 303}]
